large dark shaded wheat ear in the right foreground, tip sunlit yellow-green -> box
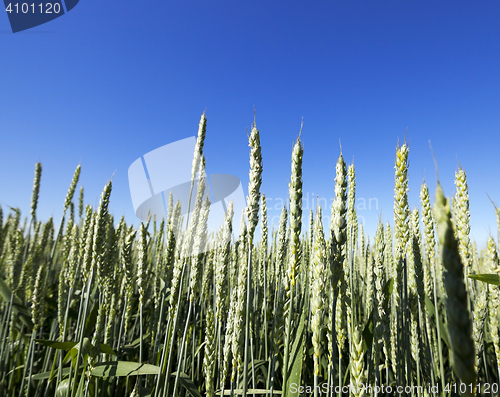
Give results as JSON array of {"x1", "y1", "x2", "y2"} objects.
[{"x1": 434, "y1": 183, "x2": 476, "y2": 396}]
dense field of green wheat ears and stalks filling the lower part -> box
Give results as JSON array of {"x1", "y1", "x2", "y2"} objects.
[{"x1": 0, "y1": 114, "x2": 500, "y2": 397}]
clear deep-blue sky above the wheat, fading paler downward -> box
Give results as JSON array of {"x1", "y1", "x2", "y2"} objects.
[{"x1": 0, "y1": 0, "x2": 500, "y2": 246}]
